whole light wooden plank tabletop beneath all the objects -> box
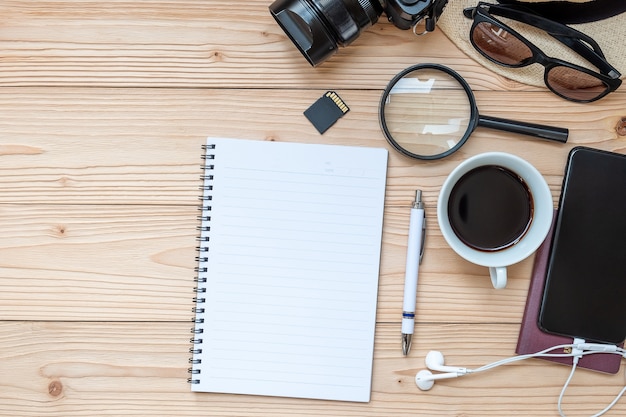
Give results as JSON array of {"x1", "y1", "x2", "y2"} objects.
[{"x1": 0, "y1": 0, "x2": 626, "y2": 417}]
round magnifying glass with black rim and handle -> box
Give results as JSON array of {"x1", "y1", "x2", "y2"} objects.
[{"x1": 380, "y1": 64, "x2": 569, "y2": 160}]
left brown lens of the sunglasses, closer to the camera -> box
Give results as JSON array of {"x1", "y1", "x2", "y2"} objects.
[{"x1": 472, "y1": 22, "x2": 533, "y2": 66}]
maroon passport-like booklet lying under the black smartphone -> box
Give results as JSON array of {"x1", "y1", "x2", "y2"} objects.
[{"x1": 515, "y1": 211, "x2": 622, "y2": 374}]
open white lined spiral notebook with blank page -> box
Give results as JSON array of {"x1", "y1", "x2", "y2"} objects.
[{"x1": 189, "y1": 138, "x2": 387, "y2": 402}]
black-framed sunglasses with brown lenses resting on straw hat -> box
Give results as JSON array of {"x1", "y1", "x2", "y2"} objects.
[{"x1": 463, "y1": 2, "x2": 622, "y2": 103}]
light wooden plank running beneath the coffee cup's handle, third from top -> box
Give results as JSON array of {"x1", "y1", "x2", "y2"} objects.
[{"x1": 0, "y1": 204, "x2": 532, "y2": 324}]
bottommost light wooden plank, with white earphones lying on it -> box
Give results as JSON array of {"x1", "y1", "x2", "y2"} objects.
[{"x1": 0, "y1": 322, "x2": 626, "y2": 417}]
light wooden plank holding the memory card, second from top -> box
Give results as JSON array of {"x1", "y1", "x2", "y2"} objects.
[{"x1": 0, "y1": 87, "x2": 626, "y2": 207}]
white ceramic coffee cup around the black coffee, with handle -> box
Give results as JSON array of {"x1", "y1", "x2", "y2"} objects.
[{"x1": 437, "y1": 152, "x2": 554, "y2": 289}]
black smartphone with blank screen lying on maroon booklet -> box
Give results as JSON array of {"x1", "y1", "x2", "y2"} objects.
[{"x1": 539, "y1": 147, "x2": 626, "y2": 344}]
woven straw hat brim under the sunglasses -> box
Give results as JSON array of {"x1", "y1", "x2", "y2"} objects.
[{"x1": 437, "y1": 0, "x2": 626, "y2": 87}]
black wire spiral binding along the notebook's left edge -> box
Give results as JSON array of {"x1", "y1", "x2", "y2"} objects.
[{"x1": 187, "y1": 145, "x2": 215, "y2": 384}]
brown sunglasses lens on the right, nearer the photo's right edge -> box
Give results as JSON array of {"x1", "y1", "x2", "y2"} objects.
[{"x1": 546, "y1": 66, "x2": 609, "y2": 101}]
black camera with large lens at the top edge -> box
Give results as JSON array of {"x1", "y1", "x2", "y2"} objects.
[{"x1": 270, "y1": 0, "x2": 448, "y2": 66}]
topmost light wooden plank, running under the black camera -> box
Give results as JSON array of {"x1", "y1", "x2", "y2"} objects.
[{"x1": 0, "y1": 0, "x2": 536, "y2": 91}]
